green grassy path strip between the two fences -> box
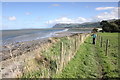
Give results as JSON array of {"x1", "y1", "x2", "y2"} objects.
[{"x1": 53, "y1": 35, "x2": 99, "y2": 78}]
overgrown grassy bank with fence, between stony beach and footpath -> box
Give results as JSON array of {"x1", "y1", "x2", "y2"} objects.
[{"x1": 22, "y1": 34, "x2": 87, "y2": 78}]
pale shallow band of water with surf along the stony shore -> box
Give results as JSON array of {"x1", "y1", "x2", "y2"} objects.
[{"x1": 3, "y1": 29, "x2": 69, "y2": 45}]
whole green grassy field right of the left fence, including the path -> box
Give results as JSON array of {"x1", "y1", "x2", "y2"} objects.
[{"x1": 53, "y1": 33, "x2": 119, "y2": 78}]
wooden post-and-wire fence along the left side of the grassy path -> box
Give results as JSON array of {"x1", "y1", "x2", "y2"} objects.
[{"x1": 56, "y1": 34, "x2": 88, "y2": 73}]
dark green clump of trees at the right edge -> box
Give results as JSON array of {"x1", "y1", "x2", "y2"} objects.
[{"x1": 100, "y1": 19, "x2": 120, "y2": 32}]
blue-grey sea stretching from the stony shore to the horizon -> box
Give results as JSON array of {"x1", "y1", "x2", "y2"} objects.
[{"x1": 0, "y1": 28, "x2": 91, "y2": 45}]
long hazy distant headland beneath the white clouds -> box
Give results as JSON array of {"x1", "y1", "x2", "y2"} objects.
[{"x1": 53, "y1": 22, "x2": 100, "y2": 28}]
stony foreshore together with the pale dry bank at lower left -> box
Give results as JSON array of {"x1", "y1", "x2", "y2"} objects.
[{"x1": 0, "y1": 32, "x2": 90, "y2": 78}]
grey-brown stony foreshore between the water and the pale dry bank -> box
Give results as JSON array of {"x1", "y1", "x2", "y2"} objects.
[{"x1": 0, "y1": 32, "x2": 76, "y2": 61}]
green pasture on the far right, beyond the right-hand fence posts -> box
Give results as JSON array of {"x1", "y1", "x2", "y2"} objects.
[{"x1": 96, "y1": 33, "x2": 119, "y2": 77}]
